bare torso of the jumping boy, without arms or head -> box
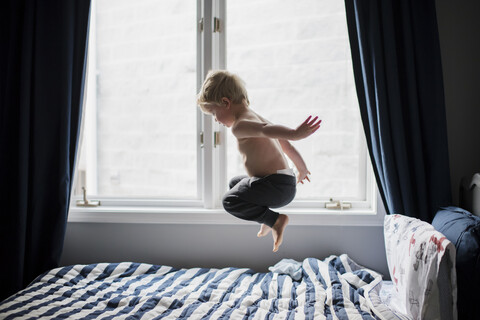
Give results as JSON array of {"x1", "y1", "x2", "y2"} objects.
[{"x1": 232, "y1": 110, "x2": 289, "y2": 177}]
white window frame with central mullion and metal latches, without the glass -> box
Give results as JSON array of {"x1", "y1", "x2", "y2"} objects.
[{"x1": 68, "y1": 0, "x2": 385, "y2": 226}]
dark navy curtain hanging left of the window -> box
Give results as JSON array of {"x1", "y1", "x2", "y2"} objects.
[{"x1": 0, "y1": 0, "x2": 90, "y2": 301}]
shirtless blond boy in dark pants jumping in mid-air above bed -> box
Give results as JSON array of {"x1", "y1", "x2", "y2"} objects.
[{"x1": 197, "y1": 70, "x2": 322, "y2": 252}]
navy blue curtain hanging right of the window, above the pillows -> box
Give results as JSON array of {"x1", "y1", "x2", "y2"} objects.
[{"x1": 345, "y1": 0, "x2": 451, "y2": 222}]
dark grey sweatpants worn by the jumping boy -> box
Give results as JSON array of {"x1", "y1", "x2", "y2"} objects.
[{"x1": 223, "y1": 174, "x2": 297, "y2": 227}]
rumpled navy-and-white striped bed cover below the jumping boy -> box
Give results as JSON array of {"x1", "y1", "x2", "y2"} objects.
[{"x1": 0, "y1": 255, "x2": 399, "y2": 319}]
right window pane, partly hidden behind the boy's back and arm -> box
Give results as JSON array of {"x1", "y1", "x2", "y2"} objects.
[{"x1": 227, "y1": 0, "x2": 365, "y2": 199}]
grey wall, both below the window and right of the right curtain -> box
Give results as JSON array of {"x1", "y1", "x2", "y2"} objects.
[{"x1": 61, "y1": 0, "x2": 480, "y2": 275}]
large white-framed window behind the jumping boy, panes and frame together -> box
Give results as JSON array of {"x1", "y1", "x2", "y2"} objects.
[{"x1": 72, "y1": 0, "x2": 375, "y2": 225}]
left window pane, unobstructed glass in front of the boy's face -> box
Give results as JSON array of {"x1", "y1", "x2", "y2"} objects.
[{"x1": 87, "y1": 0, "x2": 197, "y2": 198}]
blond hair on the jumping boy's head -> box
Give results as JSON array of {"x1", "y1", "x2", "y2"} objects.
[{"x1": 197, "y1": 70, "x2": 250, "y2": 111}]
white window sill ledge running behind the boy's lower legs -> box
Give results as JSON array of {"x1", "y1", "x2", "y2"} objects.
[{"x1": 68, "y1": 206, "x2": 384, "y2": 226}]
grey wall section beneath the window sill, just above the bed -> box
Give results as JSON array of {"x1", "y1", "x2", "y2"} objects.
[{"x1": 61, "y1": 223, "x2": 388, "y2": 274}]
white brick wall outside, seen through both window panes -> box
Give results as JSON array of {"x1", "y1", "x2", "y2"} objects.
[{"x1": 82, "y1": 0, "x2": 361, "y2": 198}]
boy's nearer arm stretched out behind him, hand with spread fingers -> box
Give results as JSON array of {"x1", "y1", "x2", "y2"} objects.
[{"x1": 232, "y1": 116, "x2": 322, "y2": 140}]
